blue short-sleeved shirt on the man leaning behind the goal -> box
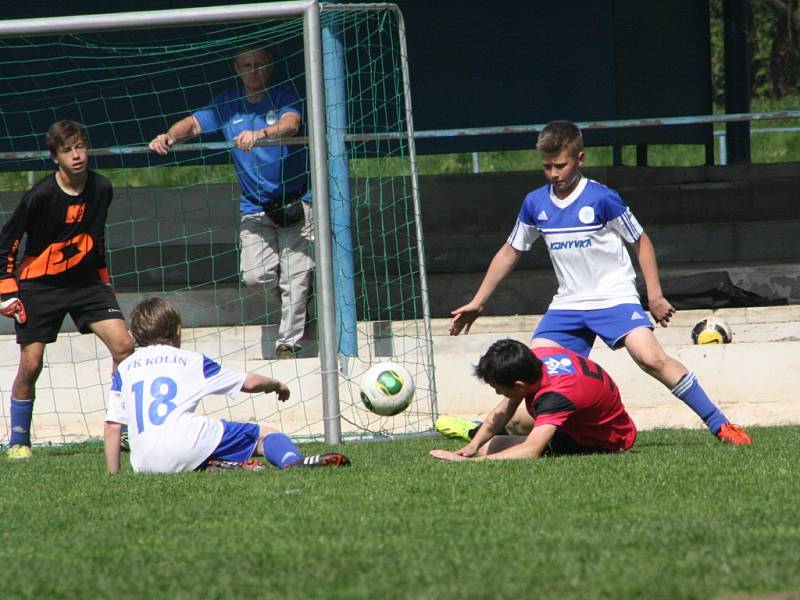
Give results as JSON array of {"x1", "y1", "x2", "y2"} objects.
[{"x1": 194, "y1": 84, "x2": 308, "y2": 215}]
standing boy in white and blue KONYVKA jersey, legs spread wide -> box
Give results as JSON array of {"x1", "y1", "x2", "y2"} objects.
[{"x1": 446, "y1": 121, "x2": 751, "y2": 445}]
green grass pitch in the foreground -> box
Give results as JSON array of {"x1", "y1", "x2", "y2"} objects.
[{"x1": 0, "y1": 427, "x2": 800, "y2": 600}]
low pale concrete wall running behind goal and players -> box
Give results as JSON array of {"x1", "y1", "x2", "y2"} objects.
[{"x1": 0, "y1": 305, "x2": 800, "y2": 443}]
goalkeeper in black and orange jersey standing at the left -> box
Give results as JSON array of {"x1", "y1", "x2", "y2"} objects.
[{"x1": 0, "y1": 120, "x2": 133, "y2": 459}]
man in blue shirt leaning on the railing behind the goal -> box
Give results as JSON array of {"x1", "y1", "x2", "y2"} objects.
[{"x1": 150, "y1": 45, "x2": 314, "y2": 358}]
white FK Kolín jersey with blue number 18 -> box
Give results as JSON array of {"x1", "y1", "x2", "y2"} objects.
[{"x1": 106, "y1": 345, "x2": 246, "y2": 473}]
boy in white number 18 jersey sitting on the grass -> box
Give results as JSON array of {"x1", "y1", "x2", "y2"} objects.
[{"x1": 103, "y1": 298, "x2": 350, "y2": 473}]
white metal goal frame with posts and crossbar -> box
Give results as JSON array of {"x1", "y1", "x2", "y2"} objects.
[{"x1": 0, "y1": 0, "x2": 437, "y2": 444}]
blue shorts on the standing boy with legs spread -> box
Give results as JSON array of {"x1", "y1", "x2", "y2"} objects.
[{"x1": 533, "y1": 304, "x2": 653, "y2": 356}]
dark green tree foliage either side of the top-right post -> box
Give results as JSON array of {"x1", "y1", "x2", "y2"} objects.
[{"x1": 710, "y1": 0, "x2": 800, "y2": 103}]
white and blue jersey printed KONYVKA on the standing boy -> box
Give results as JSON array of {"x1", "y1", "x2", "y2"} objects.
[{"x1": 508, "y1": 177, "x2": 643, "y2": 310}]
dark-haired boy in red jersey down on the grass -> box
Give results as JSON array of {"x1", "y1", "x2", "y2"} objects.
[{"x1": 431, "y1": 340, "x2": 636, "y2": 460}]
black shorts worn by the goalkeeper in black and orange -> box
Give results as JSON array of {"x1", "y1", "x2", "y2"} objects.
[{"x1": 14, "y1": 281, "x2": 125, "y2": 344}]
